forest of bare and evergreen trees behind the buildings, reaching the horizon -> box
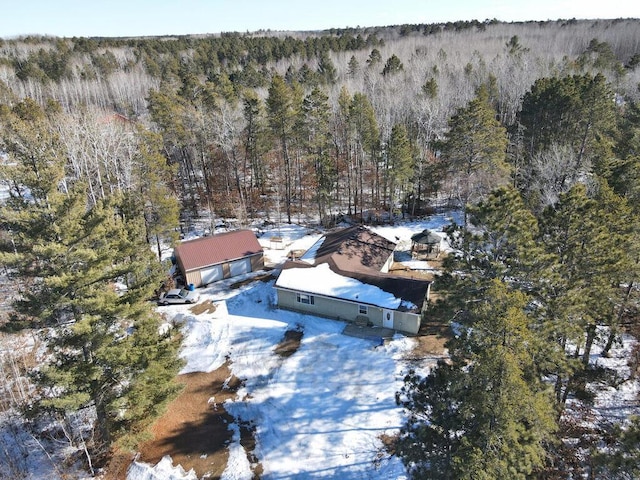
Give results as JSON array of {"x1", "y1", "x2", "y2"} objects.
[{"x1": 0, "y1": 20, "x2": 640, "y2": 229}]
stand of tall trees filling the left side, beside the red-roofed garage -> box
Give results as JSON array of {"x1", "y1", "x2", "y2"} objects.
[{"x1": 0, "y1": 99, "x2": 182, "y2": 472}]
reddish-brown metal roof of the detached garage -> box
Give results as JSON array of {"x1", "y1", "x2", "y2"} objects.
[{"x1": 175, "y1": 230, "x2": 262, "y2": 272}]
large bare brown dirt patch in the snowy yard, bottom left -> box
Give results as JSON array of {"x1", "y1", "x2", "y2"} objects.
[{"x1": 138, "y1": 363, "x2": 241, "y2": 479}]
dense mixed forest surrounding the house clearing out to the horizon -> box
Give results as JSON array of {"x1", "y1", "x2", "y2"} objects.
[{"x1": 0, "y1": 15, "x2": 640, "y2": 478}]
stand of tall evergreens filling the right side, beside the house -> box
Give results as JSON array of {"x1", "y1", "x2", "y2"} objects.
[{"x1": 397, "y1": 66, "x2": 640, "y2": 479}]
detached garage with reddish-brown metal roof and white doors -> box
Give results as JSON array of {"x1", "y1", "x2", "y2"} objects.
[{"x1": 174, "y1": 230, "x2": 264, "y2": 287}]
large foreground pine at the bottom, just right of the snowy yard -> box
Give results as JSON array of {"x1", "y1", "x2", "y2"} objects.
[{"x1": 398, "y1": 280, "x2": 556, "y2": 480}]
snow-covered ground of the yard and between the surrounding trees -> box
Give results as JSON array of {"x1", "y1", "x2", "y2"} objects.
[{"x1": 0, "y1": 215, "x2": 638, "y2": 480}]
